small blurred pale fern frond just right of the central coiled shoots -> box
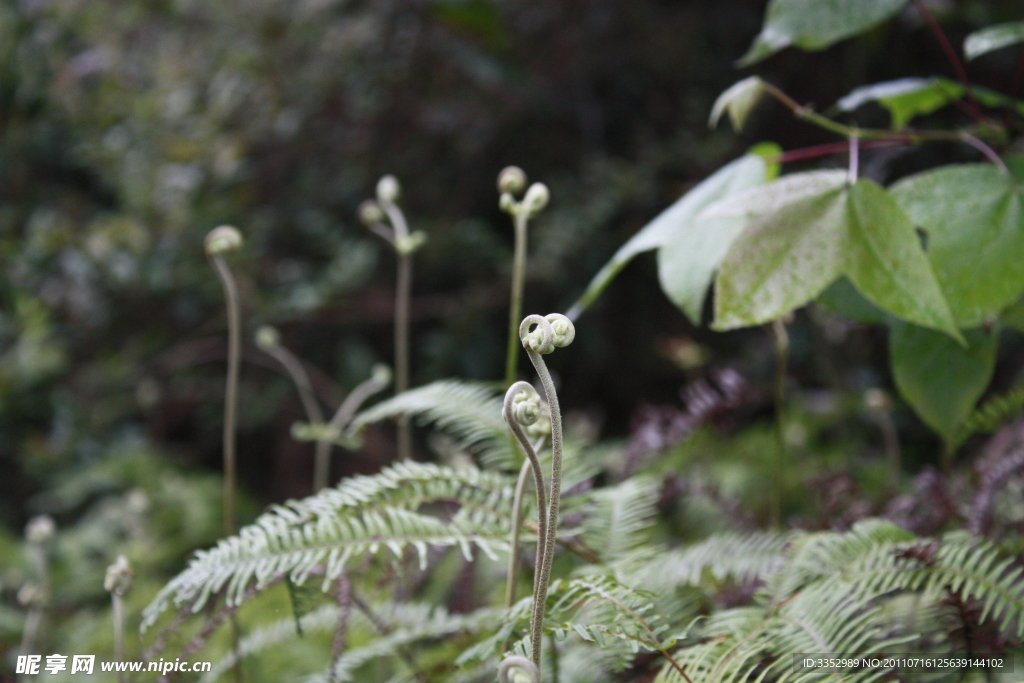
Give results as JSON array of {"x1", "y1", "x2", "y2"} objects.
[{"x1": 583, "y1": 476, "x2": 659, "y2": 560}]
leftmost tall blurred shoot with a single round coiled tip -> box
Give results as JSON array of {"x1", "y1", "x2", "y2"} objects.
[{"x1": 205, "y1": 225, "x2": 243, "y2": 536}]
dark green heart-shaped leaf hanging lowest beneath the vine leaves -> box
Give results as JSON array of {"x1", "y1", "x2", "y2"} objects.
[{"x1": 889, "y1": 323, "x2": 998, "y2": 442}]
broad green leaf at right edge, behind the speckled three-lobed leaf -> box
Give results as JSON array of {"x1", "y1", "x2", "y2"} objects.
[{"x1": 891, "y1": 164, "x2": 1024, "y2": 328}]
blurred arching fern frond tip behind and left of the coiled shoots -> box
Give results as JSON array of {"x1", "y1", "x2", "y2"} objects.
[{"x1": 349, "y1": 380, "x2": 516, "y2": 469}]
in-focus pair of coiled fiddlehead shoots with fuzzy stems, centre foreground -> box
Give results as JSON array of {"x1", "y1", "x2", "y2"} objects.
[{"x1": 505, "y1": 313, "x2": 575, "y2": 669}]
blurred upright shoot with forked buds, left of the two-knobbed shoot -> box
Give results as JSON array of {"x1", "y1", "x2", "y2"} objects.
[{"x1": 359, "y1": 175, "x2": 426, "y2": 460}]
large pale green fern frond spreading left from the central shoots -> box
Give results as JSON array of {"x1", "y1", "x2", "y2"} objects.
[{"x1": 142, "y1": 463, "x2": 512, "y2": 631}]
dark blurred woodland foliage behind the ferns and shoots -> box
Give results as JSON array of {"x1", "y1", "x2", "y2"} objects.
[{"x1": 0, "y1": 0, "x2": 1024, "y2": 671}]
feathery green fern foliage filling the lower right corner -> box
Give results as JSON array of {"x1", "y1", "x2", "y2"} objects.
[{"x1": 657, "y1": 520, "x2": 1024, "y2": 683}]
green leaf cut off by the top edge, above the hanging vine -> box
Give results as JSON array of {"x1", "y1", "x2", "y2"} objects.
[{"x1": 739, "y1": 0, "x2": 906, "y2": 67}]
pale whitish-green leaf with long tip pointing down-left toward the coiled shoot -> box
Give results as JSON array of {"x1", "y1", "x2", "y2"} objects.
[{"x1": 566, "y1": 144, "x2": 780, "y2": 323}]
